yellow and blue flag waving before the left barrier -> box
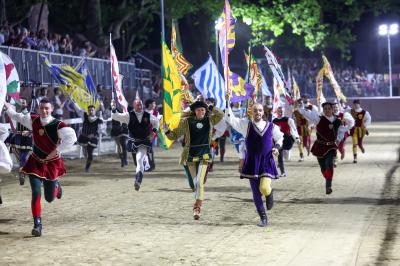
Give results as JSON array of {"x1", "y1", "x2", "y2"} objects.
[{"x1": 42, "y1": 55, "x2": 99, "y2": 110}]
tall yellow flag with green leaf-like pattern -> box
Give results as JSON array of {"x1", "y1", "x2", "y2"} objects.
[{"x1": 159, "y1": 40, "x2": 182, "y2": 149}]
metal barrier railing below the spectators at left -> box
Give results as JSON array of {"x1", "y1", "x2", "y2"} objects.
[{"x1": 0, "y1": 46, "x2": 151, "y2": 89}]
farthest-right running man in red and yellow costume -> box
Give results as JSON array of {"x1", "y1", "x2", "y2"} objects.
[{"x1": 350, "y1": 100, "x2": 371, "y2": 163}]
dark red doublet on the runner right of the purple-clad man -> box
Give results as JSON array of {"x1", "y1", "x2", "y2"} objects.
[{"x1": 311, "y1": 116, "x2": 341, "y2": 157}]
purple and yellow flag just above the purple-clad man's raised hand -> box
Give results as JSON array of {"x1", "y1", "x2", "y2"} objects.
[{"x1": 229, "y1": 71, "x2": 255, "y2": 103}]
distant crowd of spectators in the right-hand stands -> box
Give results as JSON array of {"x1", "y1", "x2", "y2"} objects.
[{"x1": 282, "y1": 59, "x2": 400, "y2": 97}]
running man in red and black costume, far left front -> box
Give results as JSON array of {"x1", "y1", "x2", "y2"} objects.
[{"x1": 5, "y1": 99, "x2": 76, "y2": 236}]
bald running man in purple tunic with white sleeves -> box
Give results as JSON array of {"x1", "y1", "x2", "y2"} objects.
[{"x1": 225, "y1": 103, "x2": 283, "y2": 227}]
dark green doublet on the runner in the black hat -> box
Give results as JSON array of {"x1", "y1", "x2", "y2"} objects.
[{"x1": 188, "y1": 117, "x2": 211, "y2": 162}]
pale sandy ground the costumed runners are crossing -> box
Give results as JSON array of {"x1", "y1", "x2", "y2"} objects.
[{"x1": 0, "y1": 123, "x2": 400, "y2": 265}]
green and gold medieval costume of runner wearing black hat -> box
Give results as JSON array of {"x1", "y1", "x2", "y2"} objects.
[{"x1": 165, "y1": 101, "x2": 224, "y2": 220}]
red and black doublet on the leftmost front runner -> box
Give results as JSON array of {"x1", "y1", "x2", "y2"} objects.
[{"x1": 22, "y1": 114, "x2": 67, "y2": 180}]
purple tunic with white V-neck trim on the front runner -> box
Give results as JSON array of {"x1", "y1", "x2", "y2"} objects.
[{"x1": 240, "y1": 122, "x2": 278, "y2": 179}]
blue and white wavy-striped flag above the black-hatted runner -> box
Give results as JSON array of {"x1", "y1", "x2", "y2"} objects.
[{"x1": 192, "y1": 55, "x2": 226, "y2": 110}]
